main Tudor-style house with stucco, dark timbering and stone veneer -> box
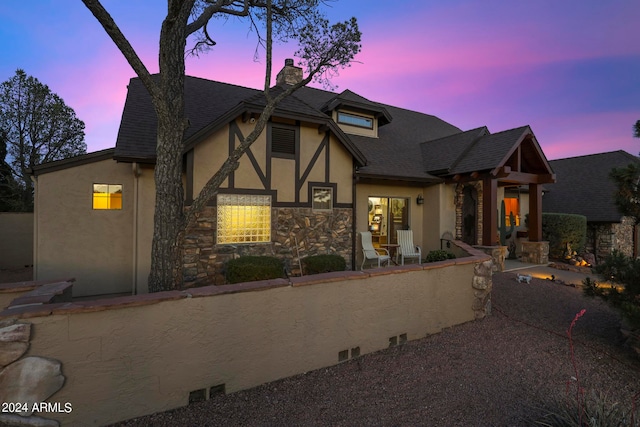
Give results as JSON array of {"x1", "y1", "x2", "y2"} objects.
[{"x1": 33, "y1": 62, "x2": 554, "y2": 295}]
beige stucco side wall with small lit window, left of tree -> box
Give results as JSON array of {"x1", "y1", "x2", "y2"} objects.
[{"x1": 34, "y1": 160, "x2": 134, "y2": 296}]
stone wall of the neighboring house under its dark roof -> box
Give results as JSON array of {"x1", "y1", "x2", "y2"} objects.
[{"x1": 585, "y1": 217, "x2": 634, "y2": 263}]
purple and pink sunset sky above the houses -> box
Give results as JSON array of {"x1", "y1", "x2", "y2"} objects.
[{"x1": 0, "y1": 0, "x2": 640, "y2": 160}]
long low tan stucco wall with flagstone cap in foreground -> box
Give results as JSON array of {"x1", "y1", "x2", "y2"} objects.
[{"x1": 3, "y1": 249, "x2": 491, "y2": 425}]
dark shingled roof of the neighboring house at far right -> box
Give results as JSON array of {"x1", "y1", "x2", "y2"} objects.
[{"x1": 542, "y1": 150, "x2": 640, "y2": 222}]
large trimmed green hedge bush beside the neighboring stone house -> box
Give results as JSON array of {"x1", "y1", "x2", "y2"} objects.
[{"x1": 542, "y1": 213, "x2": 587, "y2": 259}]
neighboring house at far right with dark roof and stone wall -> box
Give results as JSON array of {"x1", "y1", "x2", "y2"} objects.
[{"x1": 543, "y1": 150, "x2": 640, "y2": 262}]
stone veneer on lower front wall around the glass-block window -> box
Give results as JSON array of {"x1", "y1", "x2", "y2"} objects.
[{"x1": 183, "y1": 207, "x2": 353, "y2": 288}]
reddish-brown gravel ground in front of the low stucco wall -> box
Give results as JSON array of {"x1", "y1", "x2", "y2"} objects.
[{"x1": 110, "y1": 273, "x2": 640, "y2": 426}]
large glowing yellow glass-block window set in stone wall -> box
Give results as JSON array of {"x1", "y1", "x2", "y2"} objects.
[{"x1": 217, "y1": 194, "x2": 271, "y2": 244}]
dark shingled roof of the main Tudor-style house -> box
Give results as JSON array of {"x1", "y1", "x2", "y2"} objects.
[{"x1": 114, "y1": 75, "x2": 550, "y2": 183}]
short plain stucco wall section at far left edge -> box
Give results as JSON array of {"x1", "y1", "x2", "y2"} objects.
[{"x1": 0, "y1": 212, "x2": 33, "y2": 268}]
